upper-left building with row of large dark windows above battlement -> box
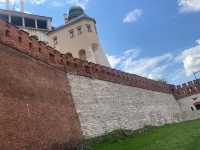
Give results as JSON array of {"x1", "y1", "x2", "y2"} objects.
[{"x1": 0, "y1": 9, "x2": 52, "y2": 43}]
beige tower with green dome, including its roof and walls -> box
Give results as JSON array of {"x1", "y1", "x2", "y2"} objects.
[{"x1": 49, "y1": 6, "x2": 110, "y2": 66}]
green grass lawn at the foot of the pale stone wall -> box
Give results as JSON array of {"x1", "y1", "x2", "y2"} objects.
[{"x1": 82, "y1": 120, "x2": 200, "y2": 150}]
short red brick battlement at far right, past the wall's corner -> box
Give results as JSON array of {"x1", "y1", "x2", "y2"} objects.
[{"x1": 172, "y1": 79, "x2": 200, "y2": 99}]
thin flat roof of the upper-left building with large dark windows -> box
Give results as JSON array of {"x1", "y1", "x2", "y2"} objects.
[{"x1": 0, "y1": 9, "x2": 52, "y2": 21}]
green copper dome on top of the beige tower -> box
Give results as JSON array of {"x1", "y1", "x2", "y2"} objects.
[{"x1": 69, "y1": 6, "x2": 84, "y2": 20}]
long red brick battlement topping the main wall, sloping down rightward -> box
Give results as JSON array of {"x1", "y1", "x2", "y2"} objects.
[{"x1": 0, "y1": 21, "x2": 172, "y2": 93}]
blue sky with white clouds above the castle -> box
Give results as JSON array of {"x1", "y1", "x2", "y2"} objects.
[{"x1": 0, "y1": 0, "x2": 200, "y2": 84}]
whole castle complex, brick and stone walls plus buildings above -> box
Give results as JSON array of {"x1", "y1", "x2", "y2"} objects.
[{"x1": 0, "y1": 4, "x2": 200, "y2": 150}]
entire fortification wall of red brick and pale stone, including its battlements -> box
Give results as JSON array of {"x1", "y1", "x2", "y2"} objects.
[{"x1": 0, "y1": 18, "x2": 200, "y2": 146}]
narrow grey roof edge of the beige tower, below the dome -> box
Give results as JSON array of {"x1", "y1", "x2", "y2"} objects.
[{"x1": 48, "y1": 14, "x2": 96, "y2": 34}]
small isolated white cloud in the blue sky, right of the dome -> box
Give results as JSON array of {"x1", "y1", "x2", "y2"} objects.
[{"x1": 123, "y1": 9, "x2": 143, "y2": 23}]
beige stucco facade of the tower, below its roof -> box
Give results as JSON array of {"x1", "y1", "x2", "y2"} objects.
[{"x1": 48, "y1": 19, "x2": 110, "y2": 66}]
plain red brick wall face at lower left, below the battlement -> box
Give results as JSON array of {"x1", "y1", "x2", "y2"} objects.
[{"x1": 0, "y1": 44, "x2": 81, "y2": 150}]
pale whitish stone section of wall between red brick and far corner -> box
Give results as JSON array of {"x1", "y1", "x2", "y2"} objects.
[{"x1": 68, "y1": 74, "x2": 181, "y2": 138}]
